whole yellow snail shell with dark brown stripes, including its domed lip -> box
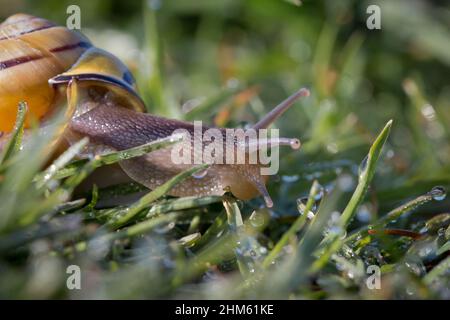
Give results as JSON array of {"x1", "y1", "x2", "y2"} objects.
[{"x1": 0, "y1": 14, "x2": 143, "y2": 132}]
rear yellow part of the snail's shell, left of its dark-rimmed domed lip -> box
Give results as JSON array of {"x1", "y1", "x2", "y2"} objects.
[{"x1": 0, "y1": 14, "x2": 92, "y2": 132}]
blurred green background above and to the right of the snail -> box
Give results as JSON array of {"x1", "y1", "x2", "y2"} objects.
[{"x1": 0, "y1": 0, "x2": 450, "y2": 300}]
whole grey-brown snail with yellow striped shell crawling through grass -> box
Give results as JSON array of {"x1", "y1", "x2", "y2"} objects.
[{"x1": 0, "y1": 14, "x2": 309, "y2": 207}]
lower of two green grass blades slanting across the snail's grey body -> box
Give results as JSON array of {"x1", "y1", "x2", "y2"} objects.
[{"x1": 107, "y1": 164, "x2": 209, "y2": 229}]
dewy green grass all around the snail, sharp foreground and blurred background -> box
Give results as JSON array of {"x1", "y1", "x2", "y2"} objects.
[{"x1": 0, "y1": 0, "x2": 450, "y2": 299}]
